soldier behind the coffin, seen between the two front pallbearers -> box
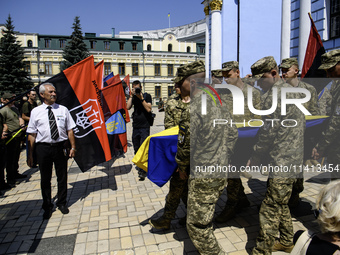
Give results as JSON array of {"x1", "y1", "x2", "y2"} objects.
[{"x1": 215, "y1": 61, "x2": 261, "y2": 223}]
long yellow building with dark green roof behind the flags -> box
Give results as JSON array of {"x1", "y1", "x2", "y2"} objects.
[{"x1": 0, "y1": 20, "x2": 205, "y2": 104}]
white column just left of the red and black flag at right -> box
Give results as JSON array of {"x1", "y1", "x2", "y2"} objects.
[{"x1": 299, "y1": 0, "x2": 311, "y2": 69}]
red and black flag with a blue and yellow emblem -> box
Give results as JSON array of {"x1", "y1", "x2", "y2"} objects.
[{"x1": 101, "y1": 77, "x2": 130, "y2": 158}]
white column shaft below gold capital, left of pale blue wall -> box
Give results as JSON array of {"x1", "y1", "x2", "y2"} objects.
[{"x1": 211, "y1": 10, "x2": 222, "y2": 70}]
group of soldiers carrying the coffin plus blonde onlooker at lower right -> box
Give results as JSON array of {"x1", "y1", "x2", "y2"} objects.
[{"x1": 143, "y1": 50, "x2": 340, "y2": 254}]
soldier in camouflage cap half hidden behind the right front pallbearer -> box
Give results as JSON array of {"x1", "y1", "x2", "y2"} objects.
[{"x1": 280, "y1": 58, "x2": 320, "y2": 208}]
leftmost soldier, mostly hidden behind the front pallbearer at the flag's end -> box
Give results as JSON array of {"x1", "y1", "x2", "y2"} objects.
[{"x1": 149, "y1": 76, "x2": 189, "y2": 229}]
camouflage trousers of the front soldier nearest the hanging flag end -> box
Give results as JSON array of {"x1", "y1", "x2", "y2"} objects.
[{"x1": 187, "y1": 178, "x2": 227, "y2": 255}]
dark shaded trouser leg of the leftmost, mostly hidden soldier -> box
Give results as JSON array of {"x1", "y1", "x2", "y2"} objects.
[{"x1": 163, "y1": 172, "x2": 188, "y2": 219}]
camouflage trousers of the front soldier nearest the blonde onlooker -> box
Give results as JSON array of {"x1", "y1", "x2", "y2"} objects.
[{"x1": 252, "y1": 177, "x2": 295, "y2": 255}]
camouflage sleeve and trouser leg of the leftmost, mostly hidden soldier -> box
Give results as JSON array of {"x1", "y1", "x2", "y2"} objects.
[{"x1": 163, "y1": 95, "x2": 189, "y2": 220}]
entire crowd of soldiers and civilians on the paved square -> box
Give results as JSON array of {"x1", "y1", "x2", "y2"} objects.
[{"x1": 0, "y1": 50, "x2": 340, "y2": 254}]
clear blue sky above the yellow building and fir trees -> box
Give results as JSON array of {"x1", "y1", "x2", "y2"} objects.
[{"x1": 0, "y1": 0, "x2": 205, "y2": 36}]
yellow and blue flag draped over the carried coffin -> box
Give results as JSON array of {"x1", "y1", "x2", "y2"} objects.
[{"x1": 132, "y1": 116, "x2": 328, "y2": 187}]
